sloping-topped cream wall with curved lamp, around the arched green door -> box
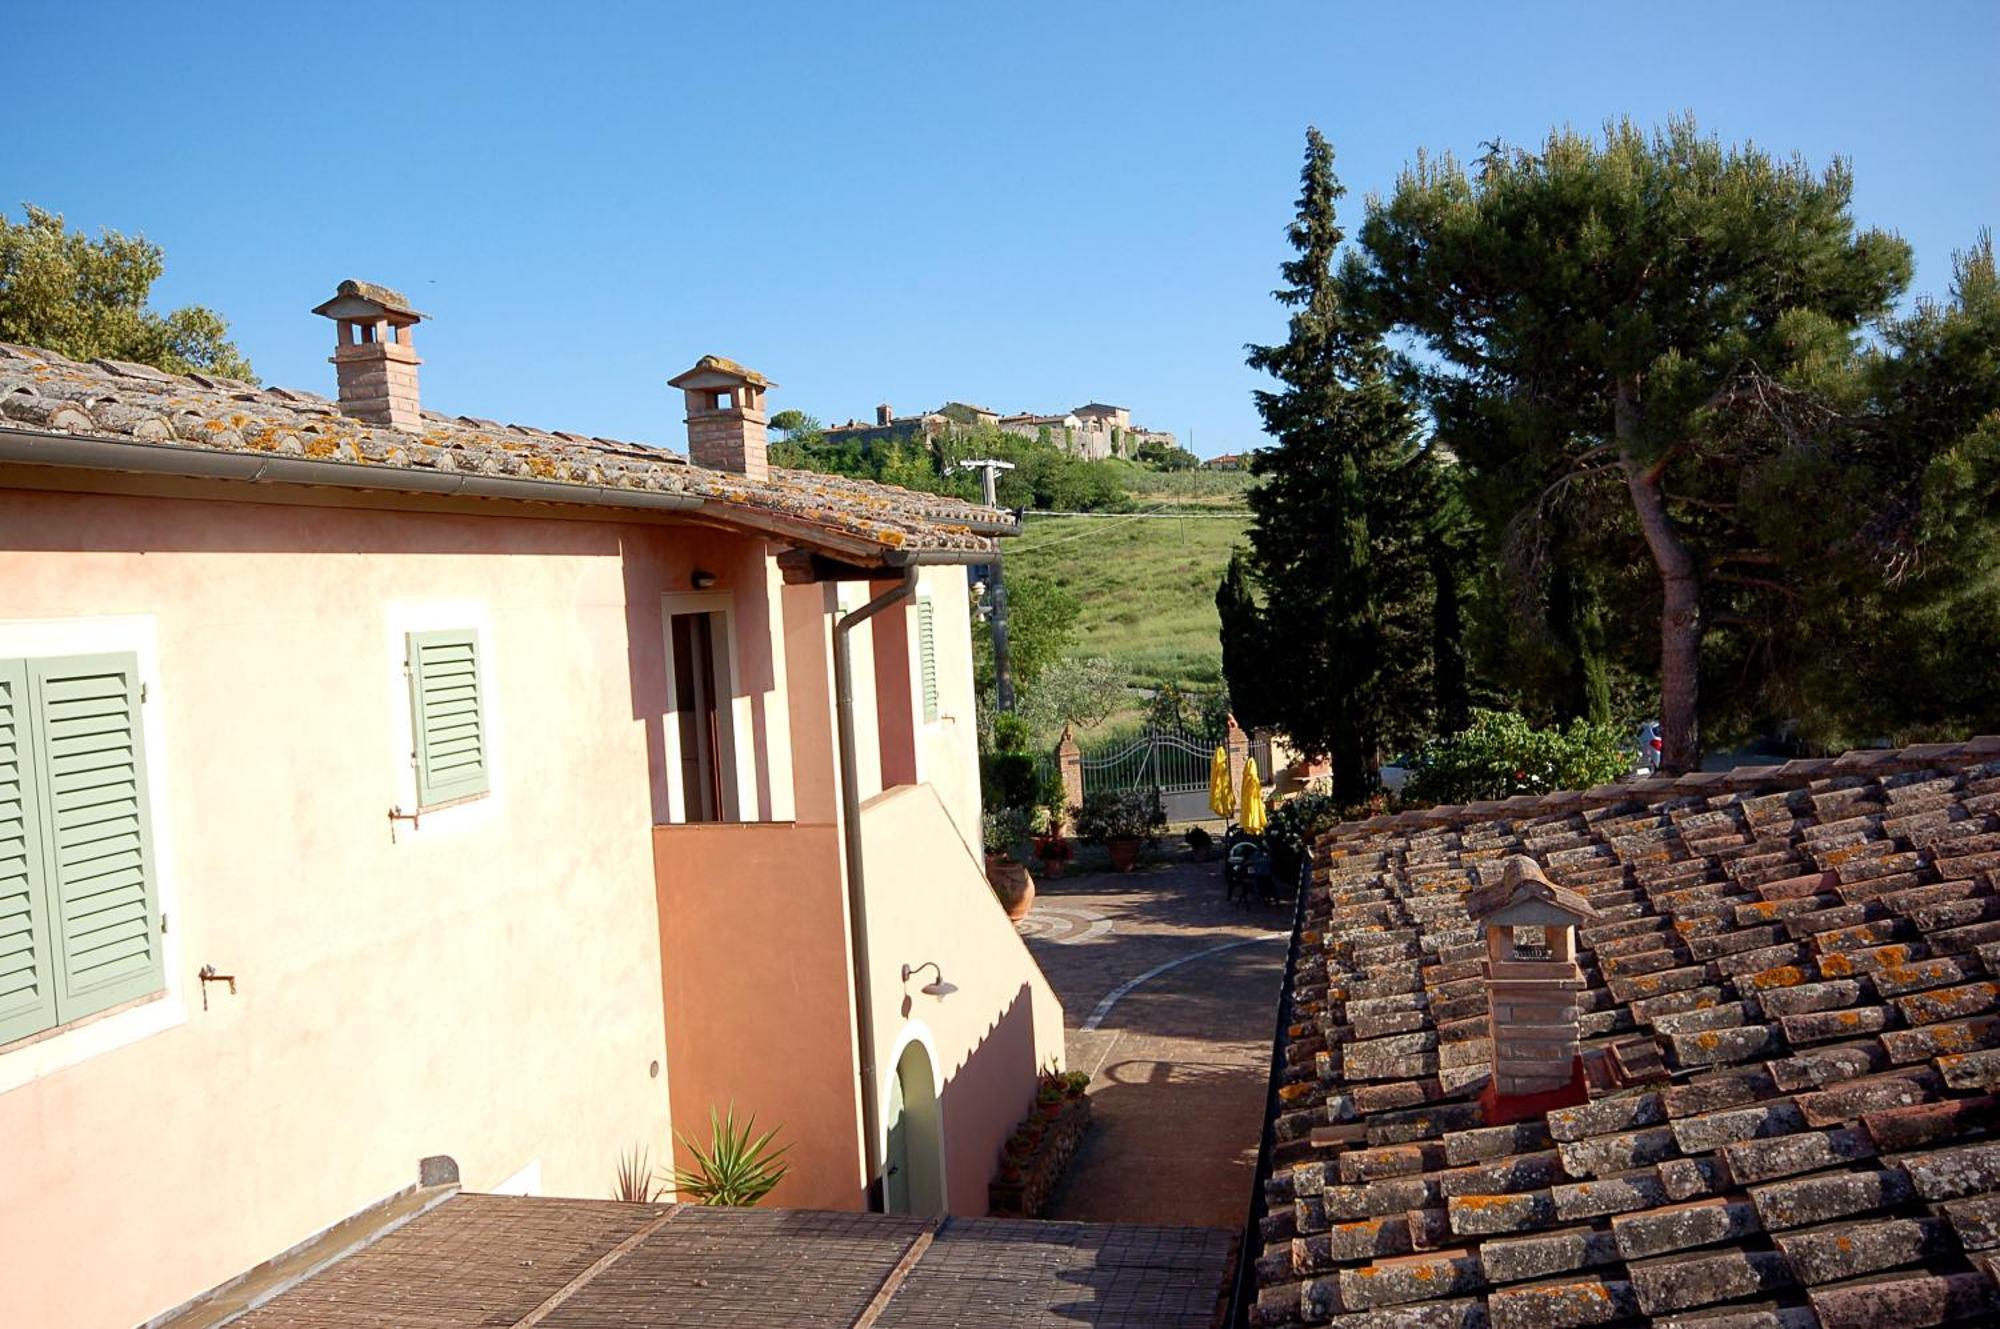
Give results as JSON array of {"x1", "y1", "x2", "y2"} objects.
[{"x1": 862, "y1": 785, "x2": 1062, "y2": 1213}]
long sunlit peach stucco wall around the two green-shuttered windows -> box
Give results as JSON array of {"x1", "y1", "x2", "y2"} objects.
[{"x1": 0, "y1": 490, "x2": 788, "y2": 1327}]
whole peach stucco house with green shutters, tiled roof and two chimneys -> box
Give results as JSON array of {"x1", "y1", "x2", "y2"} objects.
[{"x1": 0, "y1": 282, "x2": 1062, "y2": 1325}]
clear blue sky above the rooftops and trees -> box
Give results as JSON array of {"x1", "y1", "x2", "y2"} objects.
[{"x1": 15, "y1": 0, "x2": 2000, "y2": 454}]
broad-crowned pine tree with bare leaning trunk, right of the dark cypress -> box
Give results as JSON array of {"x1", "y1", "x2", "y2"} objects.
[{"x1": 1348, "y1": 120, "x2": 1910, "y2": 769}]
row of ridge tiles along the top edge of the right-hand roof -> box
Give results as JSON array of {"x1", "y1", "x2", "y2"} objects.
[{"x1": 1316, "y1": 735, "x2": 2000, "y2": 843}]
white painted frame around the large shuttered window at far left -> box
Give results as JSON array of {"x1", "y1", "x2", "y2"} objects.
[{"x1": 0, "y1": 614, "x2": 188, "y2": 1093}]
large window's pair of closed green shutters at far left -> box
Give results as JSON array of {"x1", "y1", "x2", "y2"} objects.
[{"x1": 0, "y1": 654, "x2": 164, "y2": 1043}]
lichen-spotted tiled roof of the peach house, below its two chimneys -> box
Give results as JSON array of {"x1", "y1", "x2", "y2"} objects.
[{"x1": 0, "y1": 342, "x2": 1006, "y2": 552}]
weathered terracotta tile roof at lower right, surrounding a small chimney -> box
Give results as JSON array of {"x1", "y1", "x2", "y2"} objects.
[{"x1": 1258, "y1": 739, "x2": 2000, "y2": 1329}]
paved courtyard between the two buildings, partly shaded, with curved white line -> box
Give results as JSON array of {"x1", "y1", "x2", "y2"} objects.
[{"x1": 1018, "y1": 861, "x2": 1292, "y2": 1231}]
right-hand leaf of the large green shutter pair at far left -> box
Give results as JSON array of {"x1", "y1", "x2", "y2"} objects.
[{"x1": 28, "y1": 654, "x2": 164, "y2": 1023}]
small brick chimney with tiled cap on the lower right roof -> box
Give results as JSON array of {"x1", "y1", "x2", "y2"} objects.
[{"x1": 1466, "y1": 855, "x2": 1598, "y2": 1107}]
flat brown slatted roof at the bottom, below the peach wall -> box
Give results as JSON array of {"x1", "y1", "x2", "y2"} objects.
[{"x1": 211, "y1": 1195, "x2": 1230, "y2": 1329}]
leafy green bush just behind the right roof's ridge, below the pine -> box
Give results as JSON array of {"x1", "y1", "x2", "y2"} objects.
[{"x1": 1402, "y1": 711, "x2": 1634, "y2": 803}]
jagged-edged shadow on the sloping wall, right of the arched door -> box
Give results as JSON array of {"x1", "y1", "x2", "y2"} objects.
[{"x1": 932, "y1": 983, "x2": 1040, "y2": 1213}]
